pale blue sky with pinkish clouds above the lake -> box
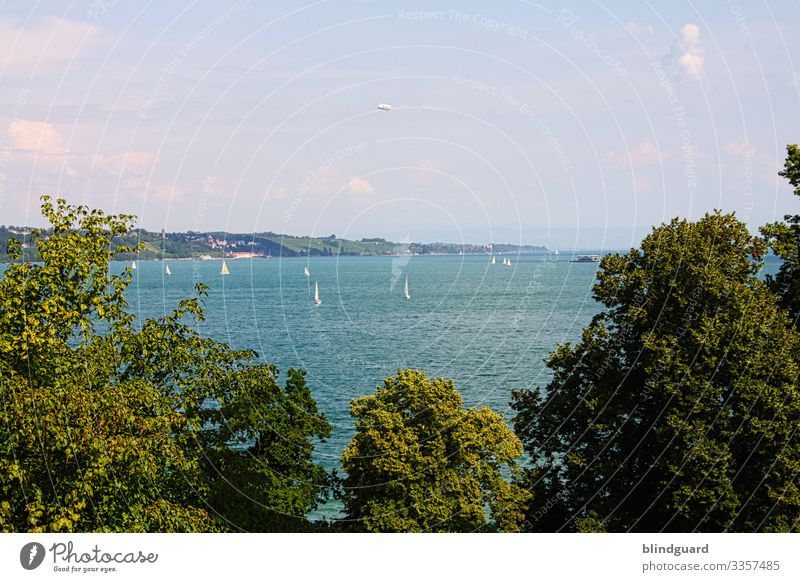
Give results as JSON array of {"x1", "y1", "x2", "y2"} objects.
[{"x1": 0, "y1": 0, "x2": 800, "y2": 248}]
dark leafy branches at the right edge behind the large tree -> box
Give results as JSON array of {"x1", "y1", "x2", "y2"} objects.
[{"x1": 761, "y1": 145, "x2": 800, "y2": 318}]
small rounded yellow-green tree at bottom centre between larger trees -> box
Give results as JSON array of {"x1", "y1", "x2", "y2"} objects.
[{"x1": 342, "y1": 370, "x2": 528, "y2": 532}]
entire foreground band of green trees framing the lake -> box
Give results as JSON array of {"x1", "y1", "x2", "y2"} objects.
[{"x1": 0, "y1": 145, "x2": 800, "y2": 533}]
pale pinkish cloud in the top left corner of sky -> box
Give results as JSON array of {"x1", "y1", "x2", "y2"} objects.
[{"x1": 0, "y1": 17, "x2": 102, "y2": 75}]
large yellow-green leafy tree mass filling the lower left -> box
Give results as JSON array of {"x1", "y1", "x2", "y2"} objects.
[{"x1": 0, "y1": 197, "x2": 332, "y2": 531}]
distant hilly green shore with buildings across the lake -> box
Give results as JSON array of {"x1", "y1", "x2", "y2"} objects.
[{"x1": 0, "y1": 226, "x2": 549, "y2": 261}]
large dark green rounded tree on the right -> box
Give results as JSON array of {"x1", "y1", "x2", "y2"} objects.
[{"x1": 513, "y1": 212, "x2": 800, "y2": 532}]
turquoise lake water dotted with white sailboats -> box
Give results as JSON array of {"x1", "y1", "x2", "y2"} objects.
[{"x1": 122, "y1": 255, "x2": 599, "y2": 467}]
